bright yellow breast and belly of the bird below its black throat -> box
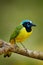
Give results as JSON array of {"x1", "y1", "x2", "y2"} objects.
[{"x1": 16, "y1": 27, "x2": 32, "y2": 42}]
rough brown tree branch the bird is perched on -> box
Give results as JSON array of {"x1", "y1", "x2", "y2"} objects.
[{"x1": 0, "y1": 40, "x2": 43, "y2": 60}]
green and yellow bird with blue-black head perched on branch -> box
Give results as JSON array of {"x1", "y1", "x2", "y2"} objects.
[{"x1": 4, "y1": 20, "x2": 36, "y2": 57}]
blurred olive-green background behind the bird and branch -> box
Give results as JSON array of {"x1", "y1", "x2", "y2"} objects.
[{"x1": 0, "y1": 0, "x2": 43, "y2": 65}]
